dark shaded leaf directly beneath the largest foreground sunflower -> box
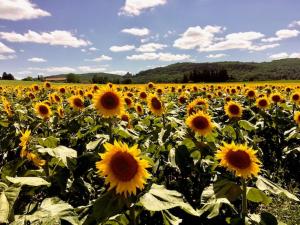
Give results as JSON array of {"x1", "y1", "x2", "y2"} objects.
[{"x1": 83, "y1": 192, "x2": 126, "y2": 225}]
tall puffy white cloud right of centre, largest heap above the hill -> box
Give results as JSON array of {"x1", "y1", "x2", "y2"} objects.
[{"x1": 173, "y1": 25, "x2": 224, "y2": 49}]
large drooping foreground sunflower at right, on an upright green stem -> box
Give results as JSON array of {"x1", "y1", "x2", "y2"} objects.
[{"x1": 216, "y1": 142, "x2": 260, "y2": 178}]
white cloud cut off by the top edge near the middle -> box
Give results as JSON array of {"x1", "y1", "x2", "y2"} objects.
[{"x1": 119, "y1": 0, "x2": 167, "y2": 16}]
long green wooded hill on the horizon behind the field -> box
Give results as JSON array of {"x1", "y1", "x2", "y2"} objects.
[{"x1": 45, "y1": 59, "x2": 300, "y2": 83}]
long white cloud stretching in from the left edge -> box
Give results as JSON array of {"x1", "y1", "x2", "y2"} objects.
[{"x1": 0, "y1": 30, "x2": 91, "y2": 48}]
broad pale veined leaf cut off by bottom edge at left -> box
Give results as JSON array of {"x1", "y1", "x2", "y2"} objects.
[{"x1": 11, "y1": 197, "x2": 81, "y2": 225}]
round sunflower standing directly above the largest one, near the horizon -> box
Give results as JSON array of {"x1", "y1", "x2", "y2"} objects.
[{"x1": 93, "y1": 88, "x2": 124, "y2": 117}]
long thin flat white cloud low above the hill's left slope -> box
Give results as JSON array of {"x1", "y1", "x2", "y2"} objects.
[{"x1": 126, "y1": 52, "x2": 191, "y2": 62}]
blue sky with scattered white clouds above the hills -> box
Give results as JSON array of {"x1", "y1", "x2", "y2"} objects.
[{"x1": 0, "y1": 0, "x2": 300, "y2": 78}]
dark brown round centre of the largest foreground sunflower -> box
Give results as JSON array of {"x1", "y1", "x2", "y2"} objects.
[{"x1": 110, "y1": 152, "x2": 138, "y2": 182}]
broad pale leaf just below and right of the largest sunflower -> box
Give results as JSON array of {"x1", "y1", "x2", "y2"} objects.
[{"x1": 140, "y1": 184, "x2": 199, "y2": 216}]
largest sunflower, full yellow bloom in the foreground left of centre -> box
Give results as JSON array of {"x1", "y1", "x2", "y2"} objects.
[{"x1": 96, "y1": 141, "x2": 150, "y2": 197}]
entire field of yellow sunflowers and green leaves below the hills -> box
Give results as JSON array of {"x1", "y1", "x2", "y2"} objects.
[{"x1": 0, "y1": 82, "x2": 300, "y2": 225}]
